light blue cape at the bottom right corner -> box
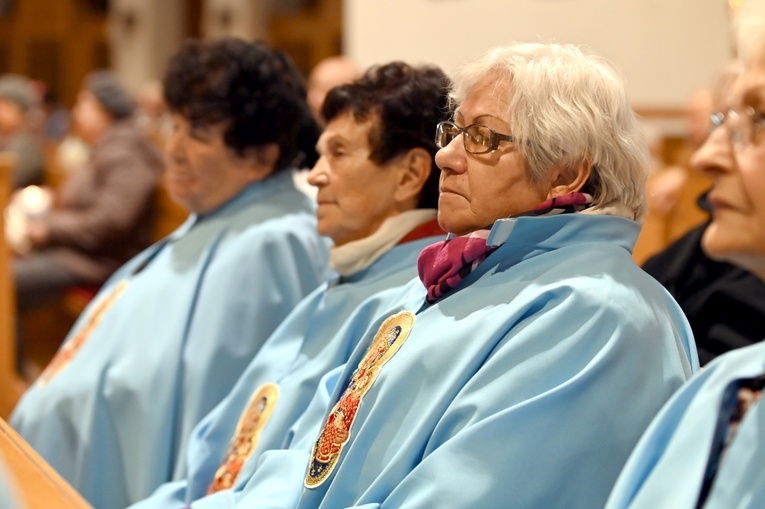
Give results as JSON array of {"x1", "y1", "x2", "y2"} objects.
[{"x1": 607, "y1": 343, "x2": 765, "y2": 509}]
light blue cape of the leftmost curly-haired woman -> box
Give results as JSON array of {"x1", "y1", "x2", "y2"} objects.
[{"x1": 10, "y1": 171, "x2": 328, "y2": 509}]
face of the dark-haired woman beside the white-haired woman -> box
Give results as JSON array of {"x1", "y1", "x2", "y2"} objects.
[{"x1": 308, "y1": 113, "x2": 400, "y2": 246}]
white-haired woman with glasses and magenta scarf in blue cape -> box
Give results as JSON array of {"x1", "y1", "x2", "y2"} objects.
[{"x1": 225, "y1": 40, "x2": 698, "y2": 509}]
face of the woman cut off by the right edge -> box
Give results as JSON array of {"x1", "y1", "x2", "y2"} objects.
[{"x1": 692, "y1": 58, "x2": 765, "y2": 277}]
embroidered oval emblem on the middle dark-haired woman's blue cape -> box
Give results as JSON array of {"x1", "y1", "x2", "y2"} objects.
[{"x1": 207, "y1": 383, "x2": 279, "y2": 495}]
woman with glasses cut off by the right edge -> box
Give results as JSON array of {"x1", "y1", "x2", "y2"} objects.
[{"x1": 608, "y1": 0, "x2": 765, "y2": 509}]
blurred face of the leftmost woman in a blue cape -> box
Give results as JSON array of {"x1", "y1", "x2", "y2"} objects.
[{"x1": 165, "y1": 114, "x2": 256, "y2": 214}]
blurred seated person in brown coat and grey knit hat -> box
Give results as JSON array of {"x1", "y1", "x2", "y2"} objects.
[{"x1": 13, "y1": 70, "x2": 163, "y2": 366}]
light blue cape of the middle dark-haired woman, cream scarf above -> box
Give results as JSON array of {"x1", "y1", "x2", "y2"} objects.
[{"x1": 132, "y1": 229, "x2": 444, "y2": 509}]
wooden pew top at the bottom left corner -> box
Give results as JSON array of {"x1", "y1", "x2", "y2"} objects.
[{"x1": 0, "y1": 419, "x2": 93, "y2": 509}]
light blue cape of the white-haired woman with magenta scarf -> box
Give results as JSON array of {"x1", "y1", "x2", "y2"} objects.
[{"x1": 231, "y1": 214, "x2": 698, "y2": 509}]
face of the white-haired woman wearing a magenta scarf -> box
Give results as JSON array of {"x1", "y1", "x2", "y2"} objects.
[{"x1": 436, "y1": 76, "x2": 551, "y2": 235}]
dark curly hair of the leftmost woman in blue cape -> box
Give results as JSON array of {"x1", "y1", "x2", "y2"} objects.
[{"x1": 163, "y1": 37, "x2": 321, "y2": 169}]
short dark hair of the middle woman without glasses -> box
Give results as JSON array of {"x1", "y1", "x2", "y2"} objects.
[{"x1": 321, "y1": 62, "x2": 450, "y2": 208}]
